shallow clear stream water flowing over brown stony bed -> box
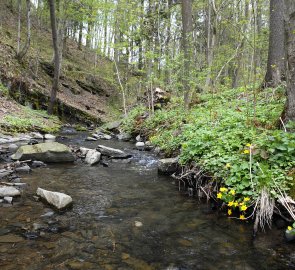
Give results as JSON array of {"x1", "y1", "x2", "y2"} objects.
[{"x1": 0, "y1": 133, "x2": 295, "y2": 270}]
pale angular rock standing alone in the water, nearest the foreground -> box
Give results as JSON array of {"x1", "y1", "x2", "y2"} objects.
[{"x1": 37, "y1": 188, "x2": 73, "y2": 209}]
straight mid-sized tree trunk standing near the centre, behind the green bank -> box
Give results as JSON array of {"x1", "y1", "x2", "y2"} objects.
[{"x1": 181, "y1": 0, "x2": 193, "y2": 108}]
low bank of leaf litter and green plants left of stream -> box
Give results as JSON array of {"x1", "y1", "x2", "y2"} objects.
[{"x1": 0, "y1": 84, "x2": 61, "y2": 133}]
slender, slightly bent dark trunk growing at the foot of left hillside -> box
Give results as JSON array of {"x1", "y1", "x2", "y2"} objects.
[{"x1": 48, "y1": 0, "x2": 61, "y2": 114}]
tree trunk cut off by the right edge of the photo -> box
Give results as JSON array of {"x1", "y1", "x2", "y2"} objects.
[{"x1": 284, "y1": 0, "x2": 295, "y2": 121}]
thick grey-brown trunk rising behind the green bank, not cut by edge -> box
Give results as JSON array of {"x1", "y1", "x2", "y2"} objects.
[{"x1": 264, "y1": 0, "x2": 285, "y2": 87}]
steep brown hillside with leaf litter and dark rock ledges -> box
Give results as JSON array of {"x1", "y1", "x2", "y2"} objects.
[{"x1": 0, "y1": 2, "x2": 121, "y2": 123}]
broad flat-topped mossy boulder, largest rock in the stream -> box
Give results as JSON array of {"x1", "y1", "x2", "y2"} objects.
[{"x1": 11, "y1": 142, "x2": 75, "y2": 163}]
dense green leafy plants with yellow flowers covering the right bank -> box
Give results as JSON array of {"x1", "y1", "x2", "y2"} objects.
[{"x1": 123, "y1": 88, "x2": 295, "y2": 226}]
